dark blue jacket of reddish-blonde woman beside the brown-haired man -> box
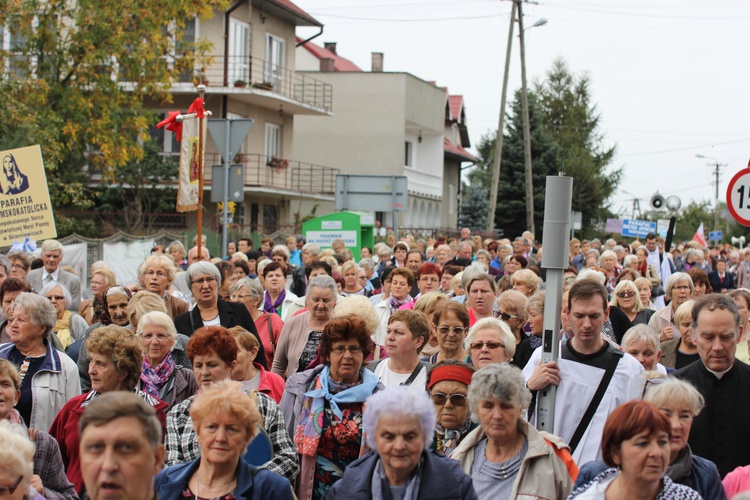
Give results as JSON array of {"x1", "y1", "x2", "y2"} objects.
[{"x1": 154, "y1": 458, "x2": 294, "y2": 500}]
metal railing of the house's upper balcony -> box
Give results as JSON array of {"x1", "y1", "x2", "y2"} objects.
[{"x1": 179, "y1": 55, "x2": 333, "y2": 112}]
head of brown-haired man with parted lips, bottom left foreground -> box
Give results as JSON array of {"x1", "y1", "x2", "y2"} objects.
[{"x1": 79, "y1": 392, "x2": 164, "y2": 500}]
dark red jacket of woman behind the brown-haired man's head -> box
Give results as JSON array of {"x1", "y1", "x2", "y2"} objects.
[{"x1": 49, "y1": 390, "x2": 169, "y2": 495}]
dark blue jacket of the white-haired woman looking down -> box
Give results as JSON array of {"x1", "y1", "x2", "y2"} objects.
[{"x1": 327, "y1": 451, "x2": 479, "y2": 500}]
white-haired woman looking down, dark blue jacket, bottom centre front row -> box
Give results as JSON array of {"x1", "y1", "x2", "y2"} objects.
[{"x1": 328, "y1": 386, "x2": 477, "y2": 500}]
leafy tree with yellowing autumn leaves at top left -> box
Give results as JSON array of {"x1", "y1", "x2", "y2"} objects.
[{"x1": 0, "y1": 0, "x2": 228, "y2": 215}]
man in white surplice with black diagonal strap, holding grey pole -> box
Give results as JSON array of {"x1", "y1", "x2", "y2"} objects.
[{"x1": 523, "y1": 279, "x2": 643, "y2": 467}]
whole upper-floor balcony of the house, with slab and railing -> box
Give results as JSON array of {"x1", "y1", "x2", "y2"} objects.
[{"x1": 172, "y1": 55, "x2": 333, "y2": 115}]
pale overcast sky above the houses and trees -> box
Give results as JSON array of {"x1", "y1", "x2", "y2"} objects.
[{"x1": 295, "y1": 0, "x2": 750, "y2": 225}]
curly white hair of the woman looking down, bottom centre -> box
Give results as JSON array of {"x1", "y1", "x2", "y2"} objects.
[{"x1": 362, "y1": 385, "x2": 437, "y2": 450}]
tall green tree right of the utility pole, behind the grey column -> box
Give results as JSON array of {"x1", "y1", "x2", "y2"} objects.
[{"x1": 536, "y1": 59, "x2": 622, "y2": 237}]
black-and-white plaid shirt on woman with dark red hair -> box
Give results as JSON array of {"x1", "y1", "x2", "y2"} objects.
[{"x1": 164, "y1": 392, "x2": 299, "y2": 481}]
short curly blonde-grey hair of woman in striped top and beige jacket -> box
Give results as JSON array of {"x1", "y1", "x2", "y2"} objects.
[{"x1": 469, "y1": 363, "x2": 531, "y2": 418}]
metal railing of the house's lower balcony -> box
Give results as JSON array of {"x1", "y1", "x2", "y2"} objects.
[{"x1": 204, "y1": 153, "x2": 339, "y2": 196}]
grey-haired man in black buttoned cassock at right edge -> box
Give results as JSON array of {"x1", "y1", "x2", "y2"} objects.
[{"x1": 674, "y1": 293, "x2": 750, "y2": 477}]
